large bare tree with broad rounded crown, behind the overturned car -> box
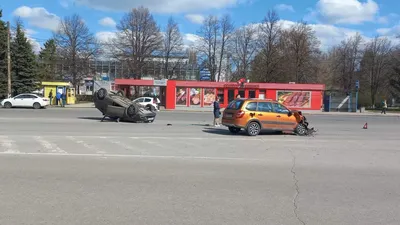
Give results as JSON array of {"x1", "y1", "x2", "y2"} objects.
[{"x1": 112, "y1": 7, "x2": 163, "y2": 79}]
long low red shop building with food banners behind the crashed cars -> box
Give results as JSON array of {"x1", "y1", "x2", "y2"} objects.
[{"x1": 115, "y1": 79, "x2": 325, "y2": 110}]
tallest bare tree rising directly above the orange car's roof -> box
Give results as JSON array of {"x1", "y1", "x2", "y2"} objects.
[{"x1": 252, "y1": 10, "x2": 283, "y2": 82}]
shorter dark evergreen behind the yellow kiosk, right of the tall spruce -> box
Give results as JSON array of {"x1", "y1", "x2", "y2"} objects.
[{"x1": 38, "y1": 39, "x2": 58, "y2": 81}]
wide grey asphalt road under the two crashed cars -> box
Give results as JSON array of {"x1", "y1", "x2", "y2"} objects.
[{"x1": 0, "y1": 109, "x2": 400, "y2": 225}]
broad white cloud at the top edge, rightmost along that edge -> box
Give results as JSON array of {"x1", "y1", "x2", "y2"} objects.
[{"x1": 313, "y1": 0, "x2": 379, "y2": 24}]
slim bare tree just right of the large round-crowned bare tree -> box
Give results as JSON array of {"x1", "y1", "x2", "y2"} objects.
[{"x1": 163, "y1": 17, "x2": 183, "y2": 79}]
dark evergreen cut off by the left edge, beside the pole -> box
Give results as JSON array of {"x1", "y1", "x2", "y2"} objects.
[{"x1": 0, "y1": 9, "x2": 7, "y2": 98}]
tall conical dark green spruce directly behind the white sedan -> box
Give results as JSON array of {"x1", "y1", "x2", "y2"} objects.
[{"x1": 11, "y1": 21, "x2": 37, "y2": 95}]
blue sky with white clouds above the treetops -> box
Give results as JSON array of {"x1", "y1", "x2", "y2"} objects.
[{"x1": 0, "y1": 0, "x2": 400, "y2": 51}]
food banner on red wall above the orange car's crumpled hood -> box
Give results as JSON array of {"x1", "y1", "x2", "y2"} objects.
[{"x1": 276, "y1": 91, "x2": 311, "y2": 108}]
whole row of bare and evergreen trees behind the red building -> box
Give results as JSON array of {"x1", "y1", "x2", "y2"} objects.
[{"x1": 0, "y1": 7, "x2": 400, "y2": 106}]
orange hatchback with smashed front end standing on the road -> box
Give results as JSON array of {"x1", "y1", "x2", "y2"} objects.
[{"x1": 222, "y1": 99, "x2": 308, "y2": 136}]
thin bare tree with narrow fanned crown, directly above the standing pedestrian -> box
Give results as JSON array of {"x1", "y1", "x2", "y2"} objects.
[{"x1": 217, "y1": 15, "x2": 235, "y2": 81}]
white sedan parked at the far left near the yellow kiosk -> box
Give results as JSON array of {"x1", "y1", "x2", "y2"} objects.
[{"x1": 1, "y1": 93, "x2": 50, "y2": 109}]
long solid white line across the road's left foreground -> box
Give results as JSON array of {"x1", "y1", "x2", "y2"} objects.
[{"x1": 0, "y1": 152, "x2": 266, "y2": 162}]
